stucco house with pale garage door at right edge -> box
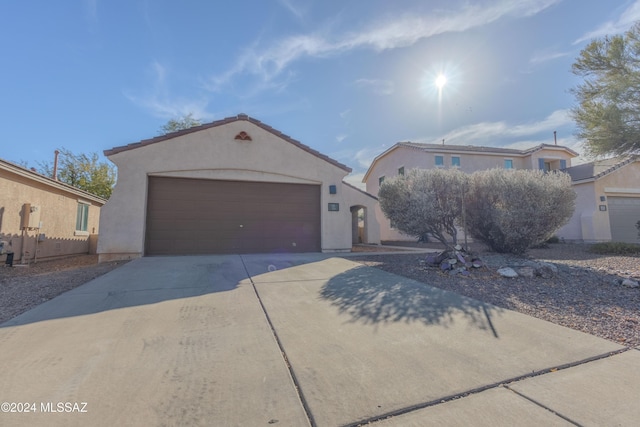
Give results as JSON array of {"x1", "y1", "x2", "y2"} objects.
[{"x1": 557, "y1": 157, "x2": 640, "y2": 243}]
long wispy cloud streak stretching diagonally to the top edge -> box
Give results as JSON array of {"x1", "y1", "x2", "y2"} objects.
[{"x1": 208, "y1": 0, "x2": 562, "y2": 90}]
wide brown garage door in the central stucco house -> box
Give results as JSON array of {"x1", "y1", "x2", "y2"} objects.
[{"x1": 145, "y1": 177, "x2": 320, "y2": 255}]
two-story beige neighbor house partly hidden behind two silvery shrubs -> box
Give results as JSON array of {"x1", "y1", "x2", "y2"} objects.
[{"x1": 363, "y1": 142, "x2": 578, "y2": 241}]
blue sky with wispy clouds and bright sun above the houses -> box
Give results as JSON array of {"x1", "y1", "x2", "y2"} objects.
[{"x1": 0, "y1": 0, "x2": 640, "y2": 184}]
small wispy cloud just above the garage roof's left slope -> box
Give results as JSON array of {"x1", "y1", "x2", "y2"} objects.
[{"x1": 123, "y1": 61, "x2": 212, "y2": 120}]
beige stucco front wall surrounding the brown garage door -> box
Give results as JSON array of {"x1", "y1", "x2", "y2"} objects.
[{"x1": 98, "y1": 120, "x2": 374, "y2": 261}]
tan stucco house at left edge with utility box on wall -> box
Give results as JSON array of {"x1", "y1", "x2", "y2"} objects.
[{"x1": 0, "y1": 160, "x2": 106, "y2": 263}]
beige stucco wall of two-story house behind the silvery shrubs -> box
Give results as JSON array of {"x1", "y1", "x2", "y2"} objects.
[{"x1": 365, "y1": 146, "x2": 572, "y2": 242}]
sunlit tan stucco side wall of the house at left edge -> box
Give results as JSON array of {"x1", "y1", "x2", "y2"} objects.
[{"x1": 0, "y1": 169, "x2": 101, "y2": 263}]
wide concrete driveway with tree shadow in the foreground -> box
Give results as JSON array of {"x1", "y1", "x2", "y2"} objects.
[{"x1": 0, "y1": 254, "x2": 640, "y2": 426}]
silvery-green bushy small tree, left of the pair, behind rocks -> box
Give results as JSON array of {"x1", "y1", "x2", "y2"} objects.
[{"x1": 378, "y1": 169, "x2": 468, "y2": 247}]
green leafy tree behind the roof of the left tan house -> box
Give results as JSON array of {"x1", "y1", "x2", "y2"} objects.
[{"x1": 40, "y1": 148, "x2": 116, "y2": 199}]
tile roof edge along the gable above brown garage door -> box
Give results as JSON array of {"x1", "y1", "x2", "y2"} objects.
[{"x1": 104, "y1": 114, "x2": 351, "y2": 172}]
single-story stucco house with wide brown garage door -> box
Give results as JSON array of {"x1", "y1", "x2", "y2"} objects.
[{"x1": 98, "y1": 114, "x2": 380, "y2": 261}]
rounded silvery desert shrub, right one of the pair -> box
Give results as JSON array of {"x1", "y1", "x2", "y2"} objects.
[{"x1": 465, "y1": 169, "x2": 576, "y2": 254}]
